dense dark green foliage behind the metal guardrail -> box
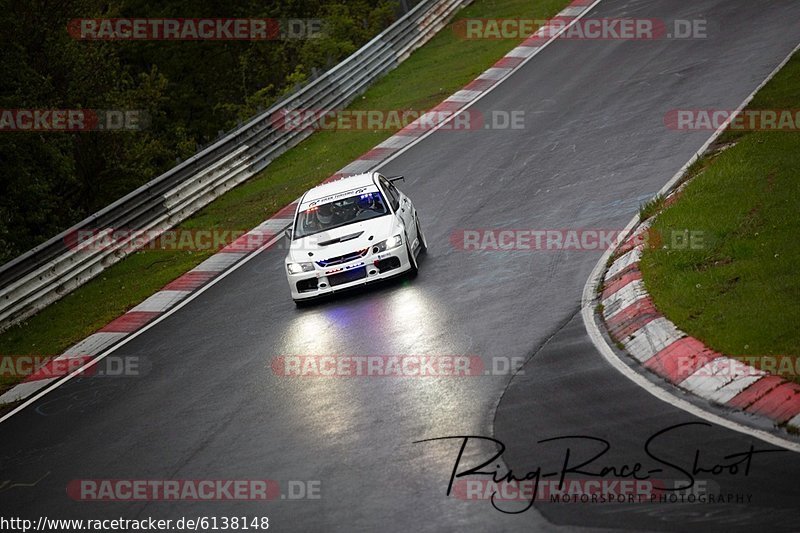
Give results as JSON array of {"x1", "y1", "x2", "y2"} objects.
[{"x1": 0, "y1": 0, "x2": 399, "y2": 264}]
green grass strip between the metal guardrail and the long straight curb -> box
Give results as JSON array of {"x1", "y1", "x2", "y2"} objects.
[{"x1": 0, "y1": 0, "x2": 568, "y2": 390}]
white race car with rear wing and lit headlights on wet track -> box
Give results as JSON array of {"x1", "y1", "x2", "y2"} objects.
[{"x1": 286, "y1": 172, "x2": 427, "y2": 305}]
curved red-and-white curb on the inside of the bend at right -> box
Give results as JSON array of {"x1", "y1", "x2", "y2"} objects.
[{"x1": 600, "y1": 221, "x2": 800, "y2": 427}]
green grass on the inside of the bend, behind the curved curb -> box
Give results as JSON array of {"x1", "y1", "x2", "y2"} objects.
[{"x1": 641, "y1": 56, "x2": 800, "y2": 382}]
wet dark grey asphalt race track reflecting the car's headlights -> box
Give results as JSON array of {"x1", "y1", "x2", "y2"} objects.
[{"x1": 0, "y1": 0, "x2": 800, "y2": 531}]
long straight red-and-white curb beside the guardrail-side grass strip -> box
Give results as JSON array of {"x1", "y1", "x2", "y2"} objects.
[{"x1": 0, "y1": 0, "x2": 601, "y2": 405}]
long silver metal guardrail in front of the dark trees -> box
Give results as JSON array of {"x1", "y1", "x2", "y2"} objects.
[{"x1": 0, "y1": 0, "x2": 472, "y2": 331}]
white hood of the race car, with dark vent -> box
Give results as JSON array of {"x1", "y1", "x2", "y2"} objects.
[{"x1": 286, "y1": 214, "x2": 402, "y2": 263}]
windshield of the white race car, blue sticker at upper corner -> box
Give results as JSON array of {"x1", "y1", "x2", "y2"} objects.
[{"x1": 293, "y1": 191, "x2": 389, "y2": 239}]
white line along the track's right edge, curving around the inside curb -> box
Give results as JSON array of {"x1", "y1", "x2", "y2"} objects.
[{"x1": 580, "y1": 41, "x2": 800, "y2": 452}]
